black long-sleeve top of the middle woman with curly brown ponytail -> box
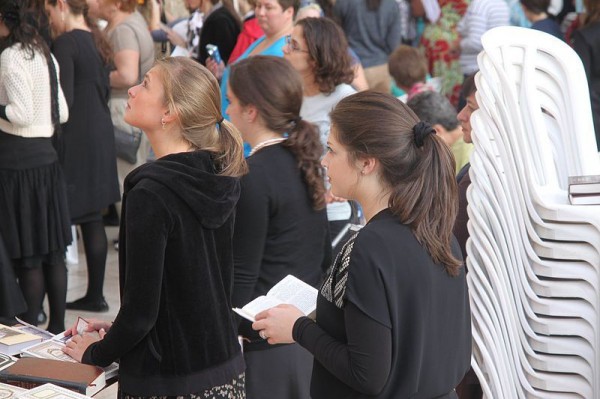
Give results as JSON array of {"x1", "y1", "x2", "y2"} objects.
[{"x1": 232, "y1": 144, "x2": 331, "y2": 351}]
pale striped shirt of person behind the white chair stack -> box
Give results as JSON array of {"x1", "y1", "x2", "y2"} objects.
[{"x1": 458, "y1": 0, "x2": 510, "y2": 75}]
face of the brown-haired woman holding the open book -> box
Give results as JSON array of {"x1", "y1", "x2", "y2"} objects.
[{"x1": 321, "y1": 124, "x2": 360, "y2": 199}]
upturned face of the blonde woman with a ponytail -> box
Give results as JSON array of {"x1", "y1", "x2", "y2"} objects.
[{"x1": 125, "y1": 67, "x2": 168, "y2": 131}]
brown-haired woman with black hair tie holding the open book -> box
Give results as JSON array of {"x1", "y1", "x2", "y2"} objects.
[{"x1": 252, "y1": 91, "x2": 471, "y2": 399}]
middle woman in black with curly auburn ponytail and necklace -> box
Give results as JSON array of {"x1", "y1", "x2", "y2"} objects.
[{"x1": 227, "y1": 56, "x2": 331, "y2": 399}]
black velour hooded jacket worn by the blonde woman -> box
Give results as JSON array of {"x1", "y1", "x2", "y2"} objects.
[{"x1": 83, "y1": 151, "x2": 244, "y2": 396}]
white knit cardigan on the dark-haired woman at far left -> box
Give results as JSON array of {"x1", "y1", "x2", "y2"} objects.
[{"x1": 0, "y1": 43, "x2": 69, "y2": 137}]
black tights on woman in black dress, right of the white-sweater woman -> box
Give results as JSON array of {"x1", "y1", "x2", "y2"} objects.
[{"x1": 80, "y1": 219, "x2": 108, "y2": 301}]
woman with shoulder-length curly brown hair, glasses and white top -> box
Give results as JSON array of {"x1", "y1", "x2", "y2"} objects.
[{"x1": 283, "y1": 18, "x2": 356, "y2": 254}]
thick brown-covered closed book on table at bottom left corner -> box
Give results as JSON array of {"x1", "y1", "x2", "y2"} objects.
[{"x1": 0, "y1": 357, "x2": 106, "y2": 396}]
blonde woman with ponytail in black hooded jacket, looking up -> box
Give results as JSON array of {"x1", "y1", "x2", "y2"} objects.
[{"x1": 65, "y1": 57, "x2": 247, "y2": 399}]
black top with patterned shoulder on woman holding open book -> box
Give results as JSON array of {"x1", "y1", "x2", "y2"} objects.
[{"x1": 293, "y1": 210, "x2": 471, "y2": 399}]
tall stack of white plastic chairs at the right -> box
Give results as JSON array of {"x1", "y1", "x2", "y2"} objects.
[{"x1": 467, "y1": 27, "x2": 600, "y2": 398}]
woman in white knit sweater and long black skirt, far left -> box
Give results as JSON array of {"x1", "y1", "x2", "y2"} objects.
[{"x1": 0, "y1": 0, "x2": 71, "y2": 333}]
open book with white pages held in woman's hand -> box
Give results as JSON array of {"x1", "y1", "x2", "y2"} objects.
[{"x1": 233, "y1": 274, "x2": 319, "y2": 322}]
